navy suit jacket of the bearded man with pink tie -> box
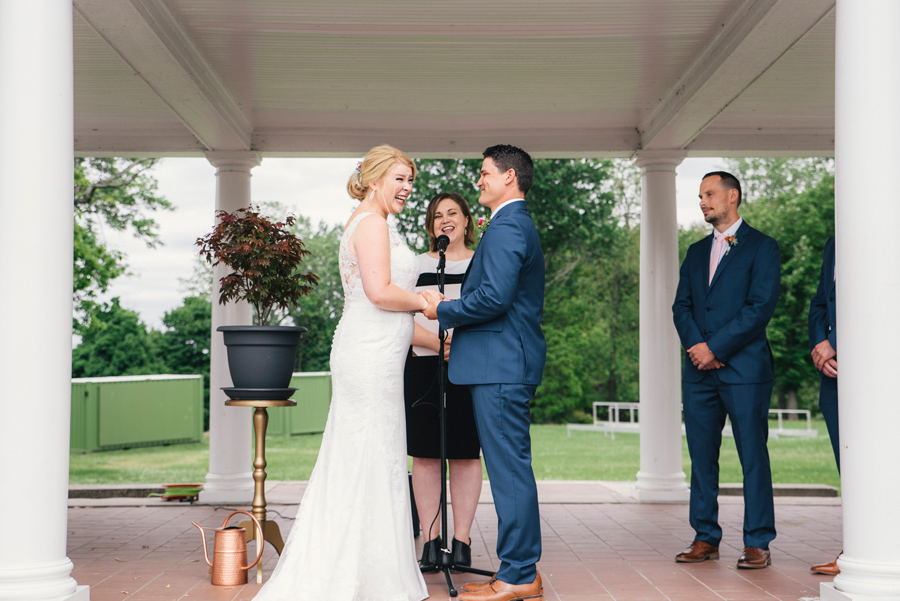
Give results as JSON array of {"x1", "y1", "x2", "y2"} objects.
[{"x1": 672, "y1": 221, "x2": 781, "y2": 384}]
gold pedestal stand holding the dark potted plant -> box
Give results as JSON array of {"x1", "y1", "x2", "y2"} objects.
[{"x1": 225, "y1": 399, "x2": 297, "y2": 584}]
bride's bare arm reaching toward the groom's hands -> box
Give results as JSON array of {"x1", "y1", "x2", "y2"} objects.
[{"x1": 350, "y1": 215, "x2": 428, "y2": 311}]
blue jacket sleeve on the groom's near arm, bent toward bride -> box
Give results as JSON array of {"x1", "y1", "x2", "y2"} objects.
[{"x1": 438, "y1": 219, "x2": 527, "y2": 328}]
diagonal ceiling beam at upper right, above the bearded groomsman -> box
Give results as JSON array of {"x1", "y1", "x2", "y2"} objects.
[{"x1": 639, "y1": 0, "x2": 834, "y2": 150}]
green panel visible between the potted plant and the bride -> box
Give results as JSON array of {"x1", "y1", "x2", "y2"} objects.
[{"x1": 266, "y1": 371, "x2": 331, "y2": 436}]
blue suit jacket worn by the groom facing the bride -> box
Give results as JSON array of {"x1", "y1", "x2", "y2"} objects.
[{"x1": 437, "y1": 202, "x2": 547, "y2": 386}]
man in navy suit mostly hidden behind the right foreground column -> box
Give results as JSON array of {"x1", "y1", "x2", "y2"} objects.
[{"x1": 809, "y1": 237, "x2": 841, "y2": 576}]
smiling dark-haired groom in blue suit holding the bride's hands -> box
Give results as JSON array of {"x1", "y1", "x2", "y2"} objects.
[{"x1": 425, "y1": 145, "x2": 547, "y2": 601}]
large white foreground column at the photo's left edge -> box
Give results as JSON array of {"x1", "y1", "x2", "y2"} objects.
[{"x1": 0, "y1": 0, "x2": 89, "y2": 601}]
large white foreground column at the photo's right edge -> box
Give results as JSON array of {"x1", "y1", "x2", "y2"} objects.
[{"x1": 821, "y1": 0, "x2": 900, "y2": 601}]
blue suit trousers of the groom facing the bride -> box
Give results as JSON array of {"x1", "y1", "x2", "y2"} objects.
[{"x1": 469, "y1": 384, "x2": 541, "y2": 584}]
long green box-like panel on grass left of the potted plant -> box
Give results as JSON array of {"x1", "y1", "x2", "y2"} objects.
[{"x1": 70, "y1": 375, "x2": 203, "y2": 452}]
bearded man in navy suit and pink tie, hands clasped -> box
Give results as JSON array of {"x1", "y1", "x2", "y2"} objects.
[{"x1": 672, "y1": 171, "x2": 781, "y2": 568}]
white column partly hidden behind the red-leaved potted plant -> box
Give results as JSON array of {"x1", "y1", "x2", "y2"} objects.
[{"x1": 200, "y1": 151, "x2": 260, "y2": 504}]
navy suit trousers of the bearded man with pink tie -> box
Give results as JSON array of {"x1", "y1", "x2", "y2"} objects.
[{"x1": 683, "y1": 371, "x2": 775, "y2": 549}]
